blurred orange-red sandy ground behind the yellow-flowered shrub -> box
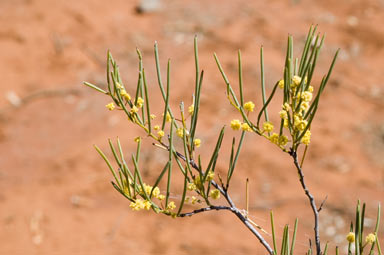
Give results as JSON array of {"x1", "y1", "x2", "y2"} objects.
[{"x1": 0, "y1": 0, "x2": 384, "y2": 255}]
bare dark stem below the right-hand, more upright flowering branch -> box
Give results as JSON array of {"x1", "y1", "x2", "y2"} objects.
[{"x1": 290, "y1": 150, "x2": 321, "y2": 255}]
